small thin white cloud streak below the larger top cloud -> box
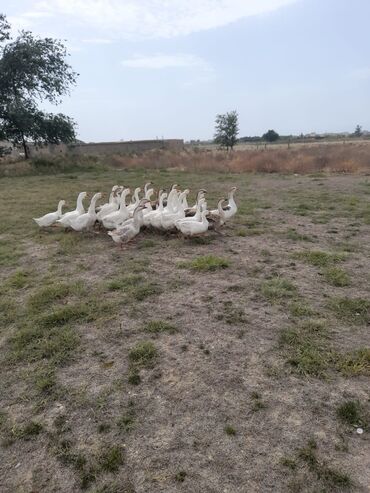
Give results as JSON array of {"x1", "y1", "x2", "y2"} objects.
[{"x1": 121, "y1": 53, "x2": 210, "y2": 71}]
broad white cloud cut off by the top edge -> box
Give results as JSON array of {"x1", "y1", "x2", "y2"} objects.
[{"x1": 33, "y1": 0, "x2": 298, "y2": 39}]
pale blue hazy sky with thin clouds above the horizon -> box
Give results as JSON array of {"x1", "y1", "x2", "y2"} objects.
[{"x1": 0, "y1": 0, "x2": 370, "y2": 142}]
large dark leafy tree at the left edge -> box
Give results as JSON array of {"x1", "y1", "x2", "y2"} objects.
[{"x1": 0, "y1": 15, "x2": 77, "y2": 159}]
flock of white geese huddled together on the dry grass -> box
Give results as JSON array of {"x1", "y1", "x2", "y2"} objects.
[{"x1": 34, "y1": 182, "x2": 237, "y2": 246}]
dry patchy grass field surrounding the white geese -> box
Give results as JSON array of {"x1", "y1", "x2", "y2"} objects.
[{"x1": 0, "y1": 166, "x2": 370, "y2": 493}]
